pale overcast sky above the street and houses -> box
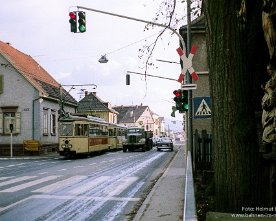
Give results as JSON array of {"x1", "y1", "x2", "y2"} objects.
[{"x1": 0, "y1": 0, "x2": 190, "y2": 130}]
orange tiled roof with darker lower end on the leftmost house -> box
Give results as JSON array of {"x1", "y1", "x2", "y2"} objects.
[{"x1": 0, "y1": 41, "x2": 77, "y2": 105}]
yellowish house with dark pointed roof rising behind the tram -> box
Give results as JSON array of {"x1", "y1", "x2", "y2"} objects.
[{"x1": 77, "y1": 91, "x2": 118, "y2": 124}]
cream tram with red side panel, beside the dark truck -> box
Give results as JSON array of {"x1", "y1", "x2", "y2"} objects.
[{"x1": 59, "y1": 115, "x2": 126, "y2": 157}]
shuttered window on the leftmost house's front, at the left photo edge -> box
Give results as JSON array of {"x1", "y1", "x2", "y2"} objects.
[{"x1": 0, "y1": 112, "x2": 21, "y2": 134}]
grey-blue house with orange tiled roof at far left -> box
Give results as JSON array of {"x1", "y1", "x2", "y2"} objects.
[{"x1": 0, "y1": 41, "x2": 77, "y2": 154}]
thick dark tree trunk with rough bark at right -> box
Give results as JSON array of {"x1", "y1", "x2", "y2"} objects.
[{"x1": 204, "y1": 0, "x2": 261, "y2": 212}]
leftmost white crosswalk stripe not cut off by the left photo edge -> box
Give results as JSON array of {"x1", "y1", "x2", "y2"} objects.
[{"x1": 32, "y1": 176, "x2": 87, "y2": 193}]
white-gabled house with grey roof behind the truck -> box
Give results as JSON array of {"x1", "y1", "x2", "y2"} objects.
[{"x1": 113, "y1": 104, "x2": 154, "y2": 131}]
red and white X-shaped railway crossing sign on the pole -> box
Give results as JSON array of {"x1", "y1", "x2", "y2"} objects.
[{"x1": 176, "y1": 45, "x2": 198, "y2": 83}]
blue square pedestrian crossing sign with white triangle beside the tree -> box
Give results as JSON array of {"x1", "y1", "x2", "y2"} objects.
[{"x1": 193, "y1": 97, "x2": 212, "y2": 118}]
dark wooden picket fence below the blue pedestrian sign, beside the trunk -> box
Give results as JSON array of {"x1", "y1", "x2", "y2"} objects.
[{"x1": 192, "y1": 130, "x2": 213, "y2": 171}]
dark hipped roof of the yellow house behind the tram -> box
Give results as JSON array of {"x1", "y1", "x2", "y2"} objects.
[{"x1": 78, "y1": 93, "x2": 117, "y2": 113}]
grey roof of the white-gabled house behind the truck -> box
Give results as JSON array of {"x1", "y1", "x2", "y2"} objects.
[{"x1": 113, "y1": 105, "x2": 148, "y2": 123}]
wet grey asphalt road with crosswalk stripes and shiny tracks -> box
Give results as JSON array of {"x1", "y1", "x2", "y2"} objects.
[{"x1": 0, "y1": 148, "x2": 178, "y2": 221}]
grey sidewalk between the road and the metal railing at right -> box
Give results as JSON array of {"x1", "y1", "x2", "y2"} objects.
[{"x1": 133, "y1": 145, "x2": 185, "y2": 221}]
